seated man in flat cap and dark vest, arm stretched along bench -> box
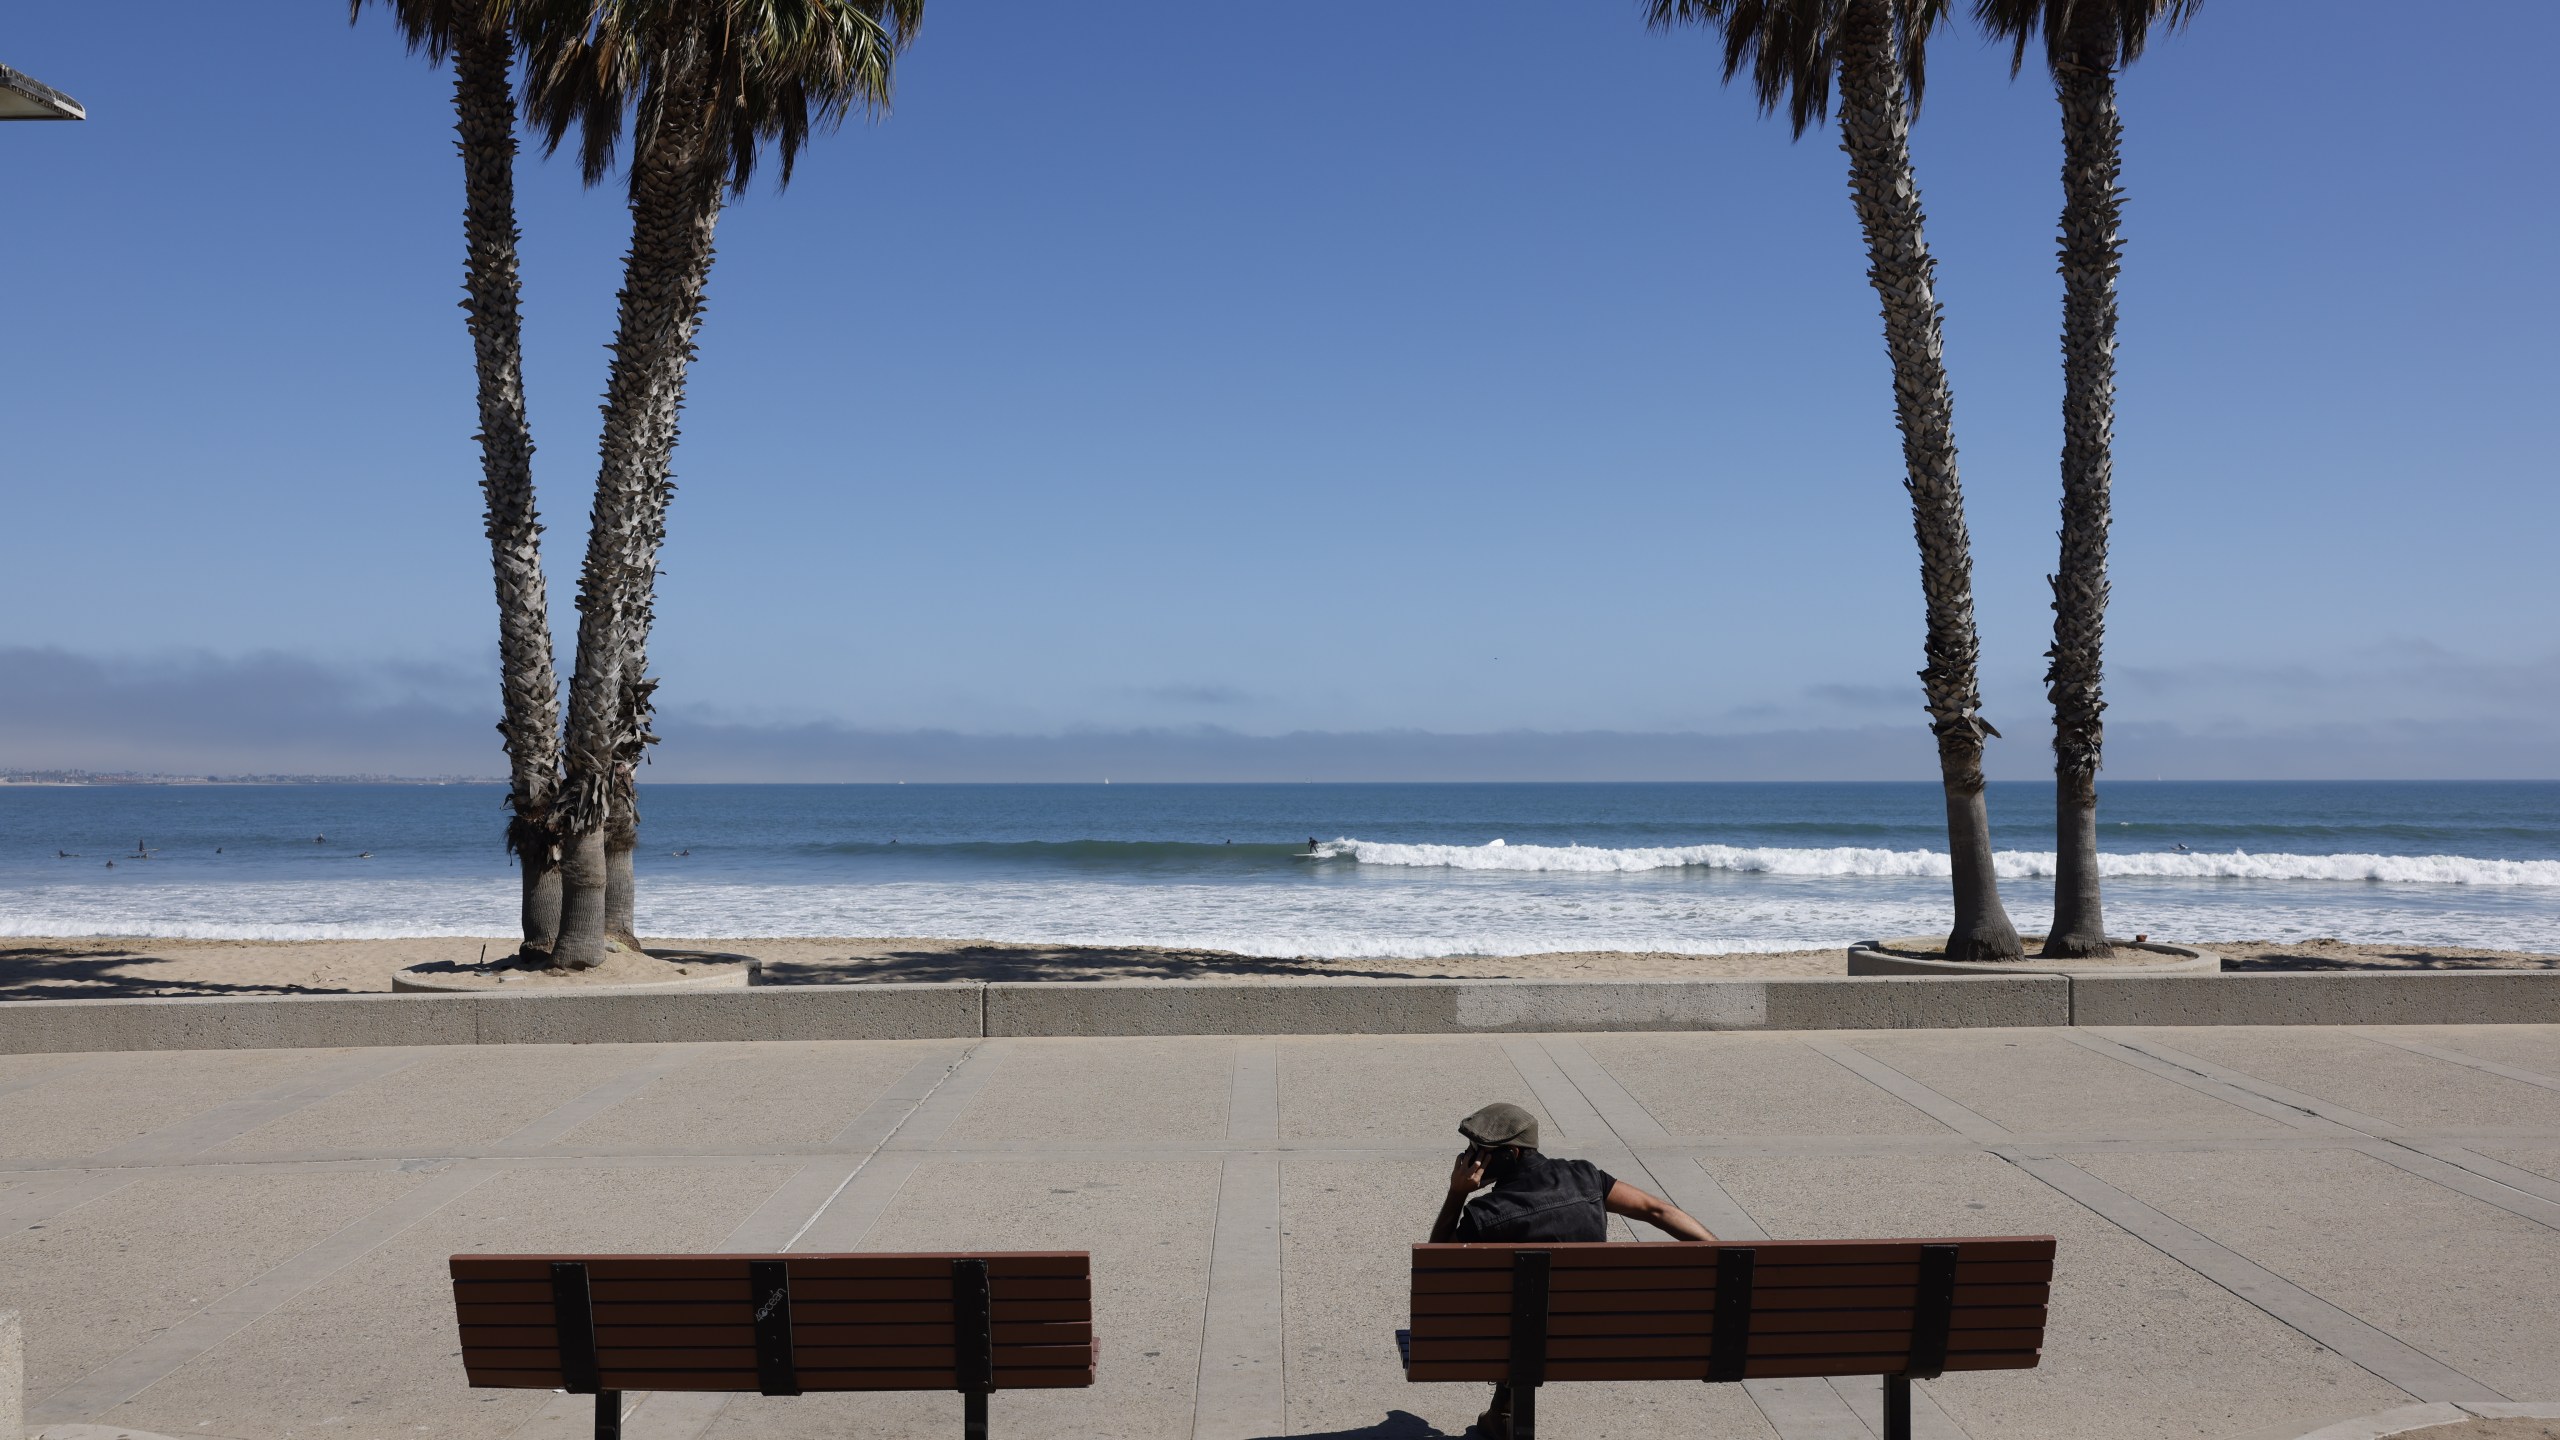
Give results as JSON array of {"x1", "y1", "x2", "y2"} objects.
[{"x1": 1431, "y1": 1102, "x2": 1715, "y2": 1435}]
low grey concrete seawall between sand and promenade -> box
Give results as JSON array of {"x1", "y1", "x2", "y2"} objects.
[{"x1": 0, "y1": 971, "x2": 2560, "y2": 1053}]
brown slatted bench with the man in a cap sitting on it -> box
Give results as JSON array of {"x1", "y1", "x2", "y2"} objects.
[{"x1": 1398, "y1": 1235, "x2": 2053, "y2": 1440}]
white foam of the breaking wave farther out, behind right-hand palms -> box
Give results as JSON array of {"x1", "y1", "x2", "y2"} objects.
[{"x1": 1321, "y1": 838, "x2": 2560, "y2": 887}]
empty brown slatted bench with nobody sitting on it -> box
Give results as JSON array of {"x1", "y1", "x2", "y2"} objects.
[{"x1": 451, "y1": 1250, "x2": 1096, "y2": 1440}]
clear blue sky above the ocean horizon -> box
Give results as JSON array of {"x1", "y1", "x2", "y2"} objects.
[{"x1": 0, "y1": 0, "x2": 2560, "y2": 779}]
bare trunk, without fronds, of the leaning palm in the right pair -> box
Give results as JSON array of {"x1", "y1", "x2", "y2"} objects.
[{"x1": 1838, "y1": 0, "x2": 2025, "y2": 961}]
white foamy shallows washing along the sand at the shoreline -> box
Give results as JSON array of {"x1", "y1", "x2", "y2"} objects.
[{"x1": 0, "y1": 846, "x2": 2560, "y2": 961}]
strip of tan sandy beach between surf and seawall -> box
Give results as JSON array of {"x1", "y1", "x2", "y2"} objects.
[{"x1": 0, "y1": 935, "x2": 2560, "y2": 999}]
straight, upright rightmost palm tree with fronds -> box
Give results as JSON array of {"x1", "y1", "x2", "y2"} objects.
[{"x1": 1974, "y1": 0, "x2": 2199, "y2": 958}]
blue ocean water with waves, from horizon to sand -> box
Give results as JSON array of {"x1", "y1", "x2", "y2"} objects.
[{"x1": 0, "y1": 781, "x2": 2560, "y2": 958}]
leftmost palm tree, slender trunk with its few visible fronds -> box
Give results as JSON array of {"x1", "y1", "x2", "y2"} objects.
[{"x1": 348, "y1": 0, "x2": 561, "y2": 958}]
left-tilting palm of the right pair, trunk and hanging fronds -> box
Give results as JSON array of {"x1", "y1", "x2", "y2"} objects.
[{"x1": 1646, "y1": 0, "x2": 2025, "y2": 961}]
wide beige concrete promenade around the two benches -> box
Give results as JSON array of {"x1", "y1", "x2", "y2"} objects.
[{"x1": 0, "y1": 1017, "x2": 2560, "y2": 1440}]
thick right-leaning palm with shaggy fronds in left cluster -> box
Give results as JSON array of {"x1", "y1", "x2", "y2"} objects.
[{"x1": 520, "y1": 0, "x2": 924, "y2": 969}]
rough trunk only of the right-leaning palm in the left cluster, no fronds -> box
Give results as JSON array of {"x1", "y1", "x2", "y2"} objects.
[{"x1": 553, "y1": 36, "x2": 722, "y2": 969}]
